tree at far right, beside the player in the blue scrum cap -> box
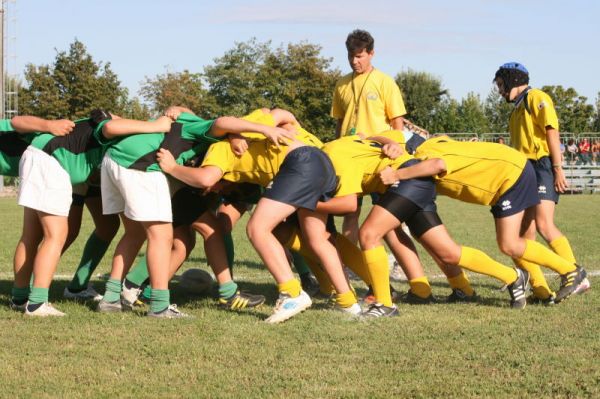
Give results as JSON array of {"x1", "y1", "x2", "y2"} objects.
[{"x1": 542, "y1": 86, "x2": 594, "y2": 133}]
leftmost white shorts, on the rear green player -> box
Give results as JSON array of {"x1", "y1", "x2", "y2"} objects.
[{"x1": 17, "y1": 146, "x2": 72, "y2": 216}]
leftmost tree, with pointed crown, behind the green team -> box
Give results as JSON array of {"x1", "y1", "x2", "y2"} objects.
[{"x1": 19, "y1": 40, "x2": 128, "y2": 119}]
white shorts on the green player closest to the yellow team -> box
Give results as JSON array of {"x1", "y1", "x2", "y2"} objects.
[{"x1": 100, "y1": 155, "x2": 173, "y2": 222}]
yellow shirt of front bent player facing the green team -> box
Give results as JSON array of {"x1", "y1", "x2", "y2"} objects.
[{"x1": 201, "y1": 110, "x2": 323, "y2": 187}]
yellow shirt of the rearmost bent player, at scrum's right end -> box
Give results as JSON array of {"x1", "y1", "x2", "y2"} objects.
[{"x1": 414, "y1": 136, "x2": 527, "y2": 205}]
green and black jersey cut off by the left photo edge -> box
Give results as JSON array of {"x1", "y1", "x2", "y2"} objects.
[{"x1": 0, "y1": 119, "x2": 35, "y2": 176}]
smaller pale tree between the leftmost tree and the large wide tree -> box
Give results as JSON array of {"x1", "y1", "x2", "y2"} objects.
[{"x1": 140, "y1": 70, "x2": 206, "y2": 115}]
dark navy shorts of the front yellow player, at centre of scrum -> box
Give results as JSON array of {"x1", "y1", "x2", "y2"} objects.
[{"x1": 264, "y1": 146, "x2": 337, "y2": 211}]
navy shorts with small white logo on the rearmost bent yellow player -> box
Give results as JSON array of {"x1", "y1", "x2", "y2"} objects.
[{"x1": 490, "y1": 162, "x2": 540, "y2": 219}]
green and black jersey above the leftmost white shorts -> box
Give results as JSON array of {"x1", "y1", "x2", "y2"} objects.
[{"x1": 31, "y1": 119, "x2": 108, "y2": 184}]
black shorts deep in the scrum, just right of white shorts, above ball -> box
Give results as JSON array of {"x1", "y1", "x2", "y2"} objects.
[{"x1": 171, "y1": 186, "x2": 221, "y2": 227}]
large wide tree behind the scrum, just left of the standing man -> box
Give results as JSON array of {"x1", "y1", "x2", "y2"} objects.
[{"x1": 203, "y1": 39, "x2": 340, "y2": 139}]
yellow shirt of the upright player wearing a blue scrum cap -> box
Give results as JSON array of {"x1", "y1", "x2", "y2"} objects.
[{"x1": 508, "y1": 89, "x2": 559, "y2": 160}]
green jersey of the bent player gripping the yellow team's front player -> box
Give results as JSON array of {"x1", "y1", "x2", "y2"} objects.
[{"x1": 107, "y1": 113, "x2": 219, "y2": 172}]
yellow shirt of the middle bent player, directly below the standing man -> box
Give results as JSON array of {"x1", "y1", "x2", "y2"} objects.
[{"x1": 323, "y1": 130, "x2": 412, "y2": 197}]
